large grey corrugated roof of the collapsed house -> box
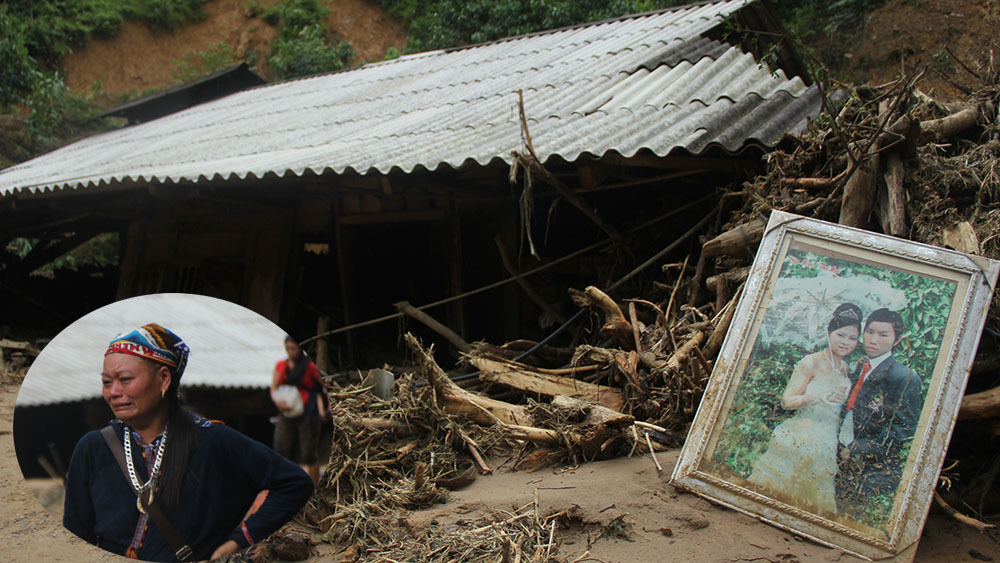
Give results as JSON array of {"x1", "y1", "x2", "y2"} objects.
[{"x1": 0, "y1": 0, "x2": 818, "y2": 193}]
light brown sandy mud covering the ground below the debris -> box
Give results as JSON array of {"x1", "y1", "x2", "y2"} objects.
[{"x1": 0, "y1": 368, "x2": 1000, "y2": 563}]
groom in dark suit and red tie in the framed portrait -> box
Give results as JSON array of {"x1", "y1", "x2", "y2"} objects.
[{"x1": 836, "y1": 309, "x2": 923, "y2": 520}]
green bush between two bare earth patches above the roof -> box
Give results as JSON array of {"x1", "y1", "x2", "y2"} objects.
[{"x1": 261, "y1": 0, "x2": 354, "y2": 80}]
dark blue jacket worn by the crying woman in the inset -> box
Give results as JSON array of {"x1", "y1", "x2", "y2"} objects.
[{"x1": 63, "y1": 421, "x2": 313, "y2": 561}]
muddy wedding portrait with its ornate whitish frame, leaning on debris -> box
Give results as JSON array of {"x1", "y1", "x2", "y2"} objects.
[{"x1": 671, "y1": 211, "x2": 1000, "y2": 560}]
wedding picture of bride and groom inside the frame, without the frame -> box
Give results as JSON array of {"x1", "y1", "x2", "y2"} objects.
[{"x1": 712, "y1": 242, "x2": 956, "y2": 530}]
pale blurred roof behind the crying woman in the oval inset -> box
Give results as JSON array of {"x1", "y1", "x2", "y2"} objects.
[{"x1": 16, "y1": 293, "x2": 285, "y2": 407}]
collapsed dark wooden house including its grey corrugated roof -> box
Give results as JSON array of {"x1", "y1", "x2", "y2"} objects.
[{"x1": 0, "y1": 0, "x2": 820, "y2": 367}]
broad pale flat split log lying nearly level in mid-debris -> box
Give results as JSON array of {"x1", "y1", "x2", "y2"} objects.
[{"x1": 468, "y1": 356, "x2": 625, "y2": 411}]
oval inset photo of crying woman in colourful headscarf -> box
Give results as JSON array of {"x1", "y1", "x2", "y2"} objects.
[{"x1": 14, "y1": 293, "x2": 330, "y2": 561}]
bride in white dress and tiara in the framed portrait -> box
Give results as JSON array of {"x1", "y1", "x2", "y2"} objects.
[{"x1": 748, "y1": 303, "x2": 861, "y2": 513}]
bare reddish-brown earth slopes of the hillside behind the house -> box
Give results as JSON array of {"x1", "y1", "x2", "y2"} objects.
[{"x1": 63, "y1": 0, "x2": 1000, "y2": 104}]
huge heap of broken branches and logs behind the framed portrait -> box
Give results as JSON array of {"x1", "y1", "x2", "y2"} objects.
[{"x1": 282, "y1": 67, "x2": 1000, "y2": 561}]
